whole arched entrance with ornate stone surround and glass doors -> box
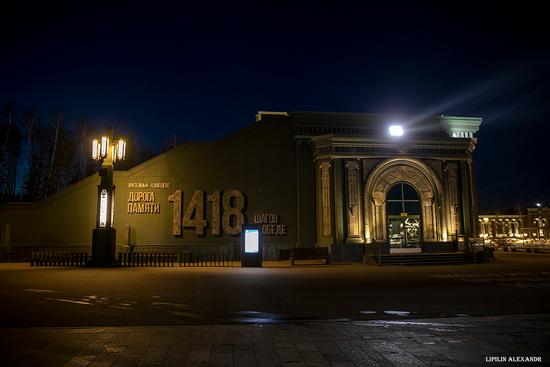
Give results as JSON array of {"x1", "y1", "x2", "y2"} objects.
[{"x1": 364, "y1": 158, "x2": 446, "y2": 252}]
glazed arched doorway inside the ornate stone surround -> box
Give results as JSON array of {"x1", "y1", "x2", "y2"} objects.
[{"x1": 386, "y1": 182, "x2": 422, "y2": 252}]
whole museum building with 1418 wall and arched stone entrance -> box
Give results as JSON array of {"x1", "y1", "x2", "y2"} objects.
[{"x1": 0, "y1": 112, "x2": 481, "y2": 261}]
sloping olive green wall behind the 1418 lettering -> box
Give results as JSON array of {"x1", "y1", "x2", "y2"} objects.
[{"x1": 0, "y1": 117, "x2": 315, "y2": 253}]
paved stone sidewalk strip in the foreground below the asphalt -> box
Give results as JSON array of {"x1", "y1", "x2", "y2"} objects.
[{"x1": 0, "y1": 314, "x2": 550, "y2": 367}]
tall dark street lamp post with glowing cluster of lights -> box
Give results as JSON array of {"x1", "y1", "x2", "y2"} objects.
[{"x1": 88, "y1": 127, "x2": 126, "y2": 267}]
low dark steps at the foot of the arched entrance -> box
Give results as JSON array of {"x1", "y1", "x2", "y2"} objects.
[{"x1": 365, "y1": 252, "x2": 474, "y2": 265}]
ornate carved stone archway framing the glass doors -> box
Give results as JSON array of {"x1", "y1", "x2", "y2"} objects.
[{"x1": 364, "y1": 158, "x2": 445, "y2": 241}]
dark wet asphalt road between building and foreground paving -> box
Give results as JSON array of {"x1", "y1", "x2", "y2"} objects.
[{"x1": 0, "y1": 253, "x2": 550, "y2": 327}]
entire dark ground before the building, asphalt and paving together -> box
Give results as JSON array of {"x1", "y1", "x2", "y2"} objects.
[{"x1": 0, "y1": 253, "x2": 550, "y2": 366}]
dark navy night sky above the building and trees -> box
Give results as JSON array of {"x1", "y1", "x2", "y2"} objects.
[{"x1": 0, "y1": 1, "x2": 550, "y2": 211}]
